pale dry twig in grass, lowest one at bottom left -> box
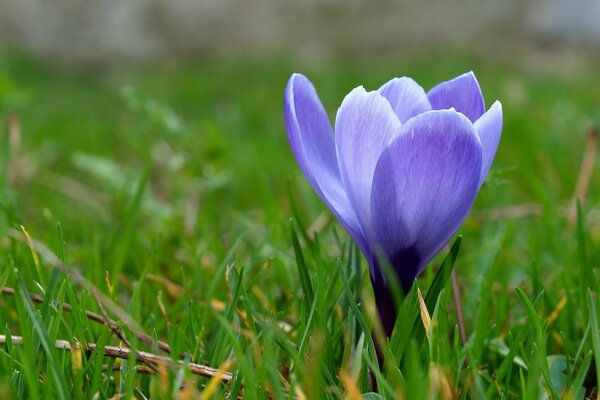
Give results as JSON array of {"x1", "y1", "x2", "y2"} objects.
[{"x1": 0, "y1": 335, "x2": 231, "y2": 383}]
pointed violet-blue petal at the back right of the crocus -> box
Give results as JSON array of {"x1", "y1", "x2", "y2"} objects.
[{"x1": 427, "y1": 72, "x2": 485, "y2": 122}]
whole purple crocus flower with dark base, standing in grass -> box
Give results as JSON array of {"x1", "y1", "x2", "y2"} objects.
[{"x1": 285, "y1": 72, "x2": 502, "y2": 336}]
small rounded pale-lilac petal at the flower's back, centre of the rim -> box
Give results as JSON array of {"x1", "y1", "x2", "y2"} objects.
[{"x1": 379, "y1": 77, "x2": 431, "y2": 123}]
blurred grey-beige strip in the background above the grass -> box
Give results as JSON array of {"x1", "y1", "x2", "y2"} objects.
[{"x1": 0, "y1": 0, "x2": 600, "y2": 63}]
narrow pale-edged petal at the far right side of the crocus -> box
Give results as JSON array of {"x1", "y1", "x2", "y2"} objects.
[{"x1": 473, "y1": 101, "x2": 502, "y2": 187}]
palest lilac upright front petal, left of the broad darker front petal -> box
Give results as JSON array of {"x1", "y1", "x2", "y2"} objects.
[{"x1": 335, "y1": 87, "x2": 401, "y2": 240}]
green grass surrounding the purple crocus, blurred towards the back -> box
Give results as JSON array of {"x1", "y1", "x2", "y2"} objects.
[{"x1": 0, "y1": 52, "x2": 600, "y2": 399}]
